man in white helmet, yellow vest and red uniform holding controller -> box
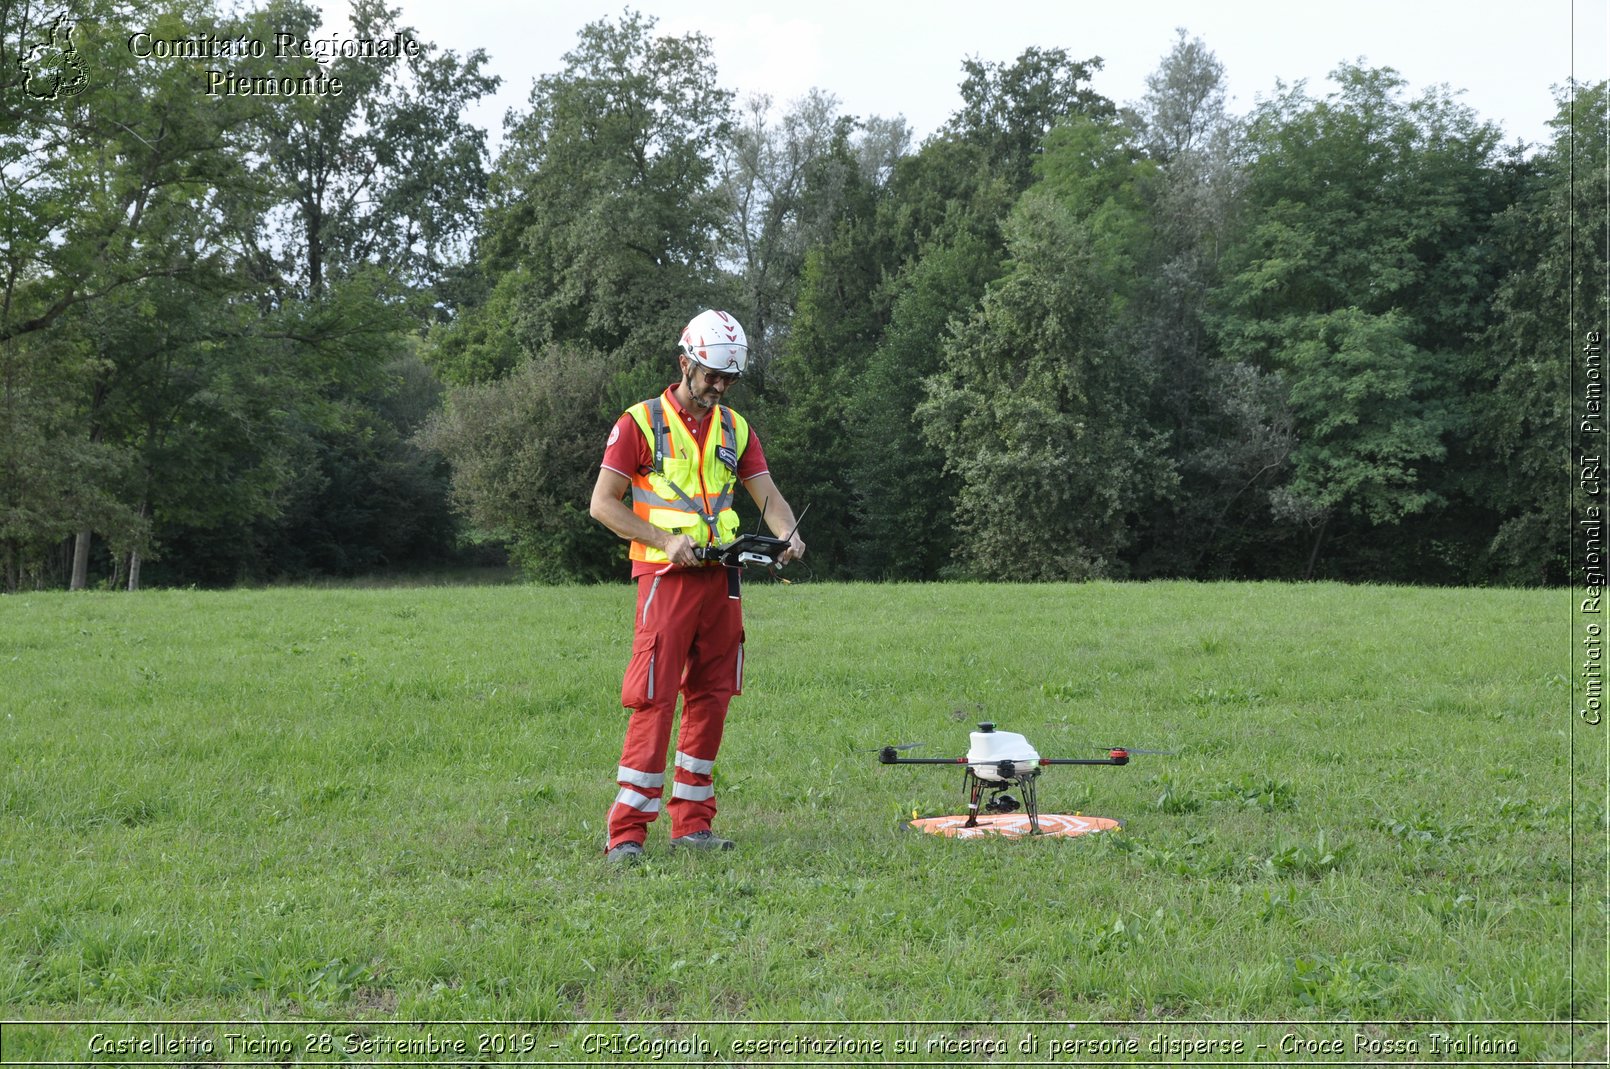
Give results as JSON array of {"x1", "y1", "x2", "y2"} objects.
[{"x1": 589, "y1": 311, "x2": 805, "y2": 861}]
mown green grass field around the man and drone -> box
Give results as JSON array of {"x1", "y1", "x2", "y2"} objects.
[{"x1": 0, "y1": 583, "x2": 1607, "y2": 1064}]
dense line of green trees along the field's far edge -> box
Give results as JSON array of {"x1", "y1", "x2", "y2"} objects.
[{"x1": 0, "y1": 0, "x2": 1610, "y2": 589}]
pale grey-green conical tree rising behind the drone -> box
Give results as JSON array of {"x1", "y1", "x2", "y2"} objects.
[{"x1": 918, "y1": 119, "x2": 1174, "y2": 580}]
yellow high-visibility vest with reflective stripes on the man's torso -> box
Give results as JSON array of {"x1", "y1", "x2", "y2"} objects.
[{"x1": 630, "y1": 396, "x2": 749, "y2": 563}]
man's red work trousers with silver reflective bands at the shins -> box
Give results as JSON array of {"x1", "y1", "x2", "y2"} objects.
[{"x1": 605, "y1": 567, "x2": 744, "y2": 850}]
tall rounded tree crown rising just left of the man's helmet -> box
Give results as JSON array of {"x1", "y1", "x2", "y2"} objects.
[{"x1": 433, "y1": 10, "x2": 731, "y2": 385}]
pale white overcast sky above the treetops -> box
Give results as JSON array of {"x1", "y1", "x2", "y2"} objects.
[{"x1": 320, "y1": 0, "x2": 1610, "y2": 148}]
